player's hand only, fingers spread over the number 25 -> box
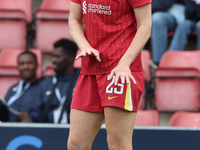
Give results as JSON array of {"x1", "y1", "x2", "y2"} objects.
[{"x1": 109, "y1": 64, "x2": 137, "y2": 85}]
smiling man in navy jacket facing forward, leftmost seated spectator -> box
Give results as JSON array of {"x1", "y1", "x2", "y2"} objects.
[{"x1": 5, "y1": 51, "x2": 41, "y2": 122}]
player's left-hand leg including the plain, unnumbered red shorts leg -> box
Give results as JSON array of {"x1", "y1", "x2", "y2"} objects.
[{"x1": 68, "y1": 74, "x2": 104, "y2": 150}]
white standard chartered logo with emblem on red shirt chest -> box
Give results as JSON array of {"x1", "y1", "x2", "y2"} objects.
[{"x1": 83, "y1": 1, "x2": 112, "y2": 15}]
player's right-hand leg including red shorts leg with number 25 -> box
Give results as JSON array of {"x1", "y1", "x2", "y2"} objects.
[{"x1": 97, "y1": 72, "x2": 143, "y2": 150}]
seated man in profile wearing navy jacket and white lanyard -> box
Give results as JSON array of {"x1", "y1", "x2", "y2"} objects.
[{"x1": 31, "y1": 39, "x2": 80, "y2": 123}]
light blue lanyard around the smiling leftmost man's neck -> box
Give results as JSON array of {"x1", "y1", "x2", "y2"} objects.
[{"x1": 7, "y1": 80, "x2": 31, "y2": 106}]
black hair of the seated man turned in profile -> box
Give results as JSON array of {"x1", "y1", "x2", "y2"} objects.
[{"x1": 54, "y1": 39, "x2": 78, "y2": 56}]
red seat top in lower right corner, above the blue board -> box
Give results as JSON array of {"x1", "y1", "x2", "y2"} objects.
[{"x1": 169, "y1": 111, "x2": 200, "y2": 127}]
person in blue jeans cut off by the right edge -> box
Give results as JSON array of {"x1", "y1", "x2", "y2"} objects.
[{"x1": 169, "y1": 0, "x2": 200, "y2": 50}]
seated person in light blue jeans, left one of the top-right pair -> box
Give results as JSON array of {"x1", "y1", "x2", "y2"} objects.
[{"x1": 151, "y1": 0, "x2": 185, "y2": 64}]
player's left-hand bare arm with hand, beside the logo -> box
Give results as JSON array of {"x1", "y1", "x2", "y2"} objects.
[{"x1": 69, "y1": 1, "x2": 101, "y2": 61}]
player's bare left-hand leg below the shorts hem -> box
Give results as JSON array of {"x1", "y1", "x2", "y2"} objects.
[{"x1": 68, "y1": 109, "x2": 104, "y2": 150}]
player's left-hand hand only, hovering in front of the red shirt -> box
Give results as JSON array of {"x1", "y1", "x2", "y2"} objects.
[{"x1": 76, "y1": 47, "x2": 101, "y2": 62}]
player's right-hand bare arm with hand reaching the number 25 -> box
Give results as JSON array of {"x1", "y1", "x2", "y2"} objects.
[{"x1": 110, "y1": 4, "x2": 152, "y2": 84}]
